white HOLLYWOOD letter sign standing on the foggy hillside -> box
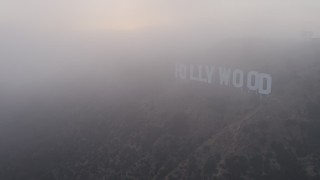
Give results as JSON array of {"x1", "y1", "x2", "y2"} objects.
[{"x1": 175, "y1": 64, "x2": 272, "y2": 95}]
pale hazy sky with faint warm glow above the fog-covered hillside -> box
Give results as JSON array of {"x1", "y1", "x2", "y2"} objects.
[{"x1": 0, "y1": 0, "x2": 320, "y2": 97}]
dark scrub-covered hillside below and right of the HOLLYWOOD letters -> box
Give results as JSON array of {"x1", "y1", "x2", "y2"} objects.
[{"x1": 0, "y1": 40, "x2": 320, "y2": 180}]
